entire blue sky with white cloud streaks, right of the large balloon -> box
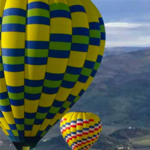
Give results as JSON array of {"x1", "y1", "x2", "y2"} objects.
[{"x1": 92, "y1": 0, "x2": 150, "y2": 47}]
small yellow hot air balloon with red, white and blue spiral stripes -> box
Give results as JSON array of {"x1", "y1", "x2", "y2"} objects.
[{"x1": 60, "y1": 112, "x2": 102, "y2": 150}]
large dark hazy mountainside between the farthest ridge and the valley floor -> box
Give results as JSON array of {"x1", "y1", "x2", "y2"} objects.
[{"x1": 72, "y1": 50, "x2": 150, "y2": 127}]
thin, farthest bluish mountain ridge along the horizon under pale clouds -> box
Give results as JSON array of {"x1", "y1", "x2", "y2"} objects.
[{"x1": 104, "y1": 47, "x2": 150, "y2": 56}]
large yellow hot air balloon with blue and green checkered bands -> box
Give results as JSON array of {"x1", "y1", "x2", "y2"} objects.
[{"x1": 0, "y1": 0, "x2": 105, "y2": 150}]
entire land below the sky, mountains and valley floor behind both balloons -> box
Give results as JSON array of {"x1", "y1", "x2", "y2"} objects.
[{"x1": 0, "y1": 47, "x2": 150, "y2": 150}]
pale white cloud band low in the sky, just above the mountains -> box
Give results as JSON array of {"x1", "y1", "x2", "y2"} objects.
[{"x1": 105, "y1": 22, "x2": 150, "y2": 47}]
